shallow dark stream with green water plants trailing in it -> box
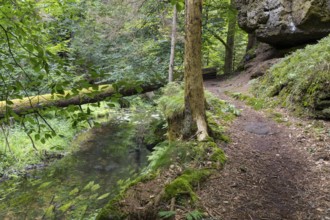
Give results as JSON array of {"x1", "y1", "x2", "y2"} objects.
[{"x1": 0, "y1": 119, "x2": 147, "y2": 219}]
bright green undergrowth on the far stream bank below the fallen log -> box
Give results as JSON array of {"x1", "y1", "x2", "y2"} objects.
[{"x1": 0, "y1": 102, "x2": 123, "y2": 177}]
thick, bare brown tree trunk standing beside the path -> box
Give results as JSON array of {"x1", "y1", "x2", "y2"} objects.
[{"x1": 183, "y1": 0, "x2": 208, "y2": 140}]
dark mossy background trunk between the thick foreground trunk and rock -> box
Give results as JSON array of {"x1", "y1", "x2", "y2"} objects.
[{"x1": 224, "y1": 0, "x2": 237, "y2": 74}]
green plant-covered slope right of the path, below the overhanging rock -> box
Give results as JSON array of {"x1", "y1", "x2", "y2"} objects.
[{"x1": 255, "y1": 37, "x2": 330, "y2": 118}]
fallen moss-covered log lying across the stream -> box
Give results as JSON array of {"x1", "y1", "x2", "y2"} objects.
[{"x1": 0, "y1": 84, "x2": 162, "y2": 118}]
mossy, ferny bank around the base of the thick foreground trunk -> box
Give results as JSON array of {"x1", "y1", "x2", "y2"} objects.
[{"x1": 97, "y1": 83, "x2": 233, "y2": 219}]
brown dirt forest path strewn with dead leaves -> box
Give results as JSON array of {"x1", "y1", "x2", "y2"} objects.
[{"x1": 198, "y1": 75, "x2": 330, "y2": 220}]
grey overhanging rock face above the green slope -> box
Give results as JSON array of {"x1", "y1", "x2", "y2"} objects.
[{"x1": 236, "y1": 0, "x2": 330, "y2": 47}]
